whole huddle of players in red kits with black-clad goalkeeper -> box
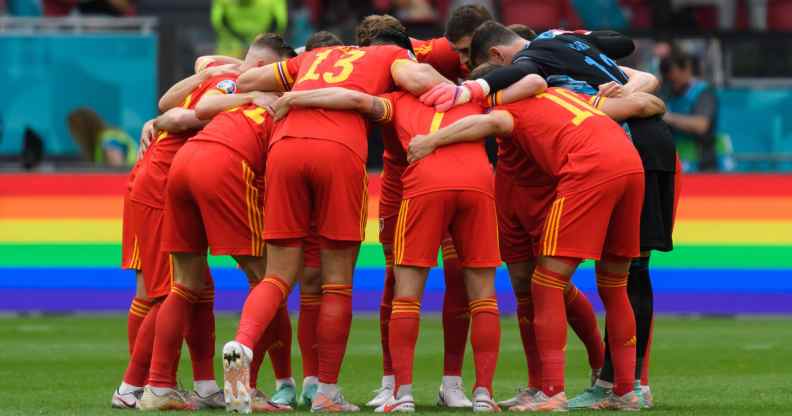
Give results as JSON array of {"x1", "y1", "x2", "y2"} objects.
[{"x1": 112, "y1": 6, "x2": 679, "y2": 413}]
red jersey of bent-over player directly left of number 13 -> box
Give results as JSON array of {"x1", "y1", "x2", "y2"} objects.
[{"x1": 190, "y1": 104, "x2": 275, "y2": 175}]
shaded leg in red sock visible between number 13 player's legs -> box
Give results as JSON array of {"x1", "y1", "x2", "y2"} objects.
[{"x1": 297, "y1": 230, "x2": 322, "y2": 407}]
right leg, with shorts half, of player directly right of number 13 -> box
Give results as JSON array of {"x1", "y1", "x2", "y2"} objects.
[{"x1": 449, "y1": 191, "x2": 501, "y2": 412}]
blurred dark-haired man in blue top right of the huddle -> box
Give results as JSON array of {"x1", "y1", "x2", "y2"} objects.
[{"x1": 660, "y1": 51, "x2": 718, "y2": 172}]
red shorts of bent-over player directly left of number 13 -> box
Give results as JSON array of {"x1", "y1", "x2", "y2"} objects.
[{"x1": 162, "y1": 141, "x2": 264, "y2": 256}]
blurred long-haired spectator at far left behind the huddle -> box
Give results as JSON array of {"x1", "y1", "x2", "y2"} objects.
[{"x1": 68, "y1": 108, "x2": 137, "y2": 167}]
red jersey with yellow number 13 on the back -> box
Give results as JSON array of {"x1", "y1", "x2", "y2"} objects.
[{"x1": 271, "y1": 45, "x2": 410, "y2": 162}]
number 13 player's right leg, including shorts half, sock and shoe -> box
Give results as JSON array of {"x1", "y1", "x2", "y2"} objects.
[{"x1": 304, "y1": 140, "x2": 368, "y2": 412}]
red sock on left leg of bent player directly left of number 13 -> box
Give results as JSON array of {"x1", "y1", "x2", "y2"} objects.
[{"x1": 149, "y1": 284, "x2": 200, "y2": 387}]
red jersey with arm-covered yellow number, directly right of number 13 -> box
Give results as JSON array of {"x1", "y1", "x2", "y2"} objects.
[{"x1": 382, "y1": 92, "x2": 494, "y2": 198}]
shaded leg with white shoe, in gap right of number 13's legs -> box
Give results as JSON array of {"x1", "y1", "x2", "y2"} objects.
[{"x1": 366, "y1": 216, "x2": 398, "y2": 408}]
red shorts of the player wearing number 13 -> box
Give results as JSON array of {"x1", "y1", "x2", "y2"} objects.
[{"x1": 264, "y1": 138, "x2": 368, "y2": 242}]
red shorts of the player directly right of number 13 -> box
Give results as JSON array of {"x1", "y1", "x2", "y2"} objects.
[{"x1": 394, "y1": 191, "x2": 501, "y2": 267}]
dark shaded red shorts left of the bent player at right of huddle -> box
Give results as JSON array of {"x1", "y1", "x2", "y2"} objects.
[{"x1": 495, "y1": 175, "x2": 555, "y2": 264}]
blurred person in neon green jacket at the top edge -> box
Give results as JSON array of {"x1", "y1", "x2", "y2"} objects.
[{"x1": 212, "y1": 0, "x2": 288, "y2": 58}]
